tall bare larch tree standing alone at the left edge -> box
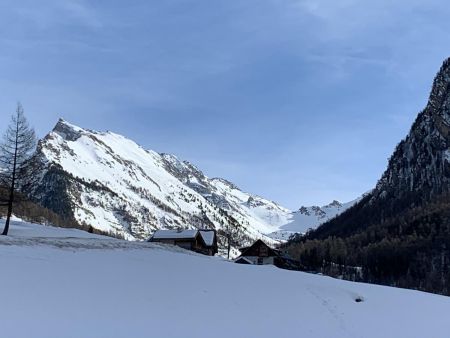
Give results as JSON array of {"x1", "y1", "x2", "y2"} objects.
[{"x1": 0, "y1": 103, "x2": 36, "y2": 235}]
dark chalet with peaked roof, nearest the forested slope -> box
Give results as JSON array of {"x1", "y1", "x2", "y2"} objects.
[{"x1": 234, "y1": 239, "x2": 300, "y2": 270}]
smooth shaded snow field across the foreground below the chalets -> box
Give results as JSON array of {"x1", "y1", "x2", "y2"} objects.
[{"x1": 0, "y1": 221, "x2": 450, "y2": 338}]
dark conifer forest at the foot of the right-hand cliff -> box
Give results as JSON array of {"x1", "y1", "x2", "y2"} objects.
[{"x1": 287, "y1": 194, "x2": 450, "y2": 295}]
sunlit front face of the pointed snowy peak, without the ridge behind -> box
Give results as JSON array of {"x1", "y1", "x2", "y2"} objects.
[{"x1": 31, "y1": 120, "x2": 276, "y2": 246}]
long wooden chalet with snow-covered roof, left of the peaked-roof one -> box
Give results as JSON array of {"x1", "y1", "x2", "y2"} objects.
[{"x1": 148, "y1": 229, "x2": 218, "y2": 256}]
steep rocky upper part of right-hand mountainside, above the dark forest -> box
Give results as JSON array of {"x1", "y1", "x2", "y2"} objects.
[{"x1": 302, "y1": 59, "x2": 450, "y2": 238}]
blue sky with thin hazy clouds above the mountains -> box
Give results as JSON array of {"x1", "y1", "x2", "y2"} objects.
[{"x1": 0, "y1": 0, "x2": 450, "y2": 209}]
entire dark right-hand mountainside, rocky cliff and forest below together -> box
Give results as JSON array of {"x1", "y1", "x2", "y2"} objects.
[{"x1": 288, "y1": 60, "x2": 450, "y2": 295}]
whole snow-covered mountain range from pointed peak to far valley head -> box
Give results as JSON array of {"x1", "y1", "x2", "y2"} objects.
[{"x1": 28, "y1": 120, "x2": 358, "y2": 244}]
